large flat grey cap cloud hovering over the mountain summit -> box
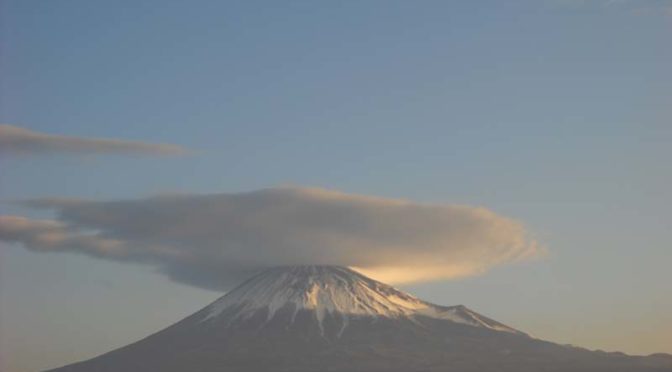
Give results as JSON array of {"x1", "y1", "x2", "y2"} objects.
[{"x1": 0, "y1": 188, "x2": 541, "y2": 289}]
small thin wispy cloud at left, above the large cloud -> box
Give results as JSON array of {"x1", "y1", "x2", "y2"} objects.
[{"x1": 0, "y1": 125, "x2": 187, "y2": 155}]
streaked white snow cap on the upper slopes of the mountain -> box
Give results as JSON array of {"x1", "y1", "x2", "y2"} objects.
[{"x1": 205, "y1": 266, "x2": 520, "y2": 333}]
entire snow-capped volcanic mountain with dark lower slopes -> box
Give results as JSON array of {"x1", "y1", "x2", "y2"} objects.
[{"x1": 52, "y1": 266, "x2": 672, "y2": 372}]
